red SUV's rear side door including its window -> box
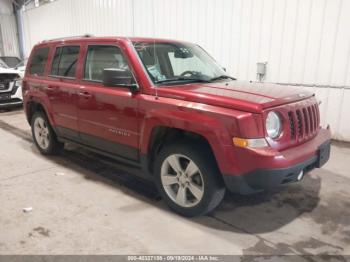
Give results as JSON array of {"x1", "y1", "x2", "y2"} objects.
[{"x1": 42, "y1": 45, "x2": 80, "y2": 140}]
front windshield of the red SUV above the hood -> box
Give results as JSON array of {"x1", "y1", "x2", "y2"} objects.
[{"x1": 133, "y1": 42, "x2": 227, "y2": 83}]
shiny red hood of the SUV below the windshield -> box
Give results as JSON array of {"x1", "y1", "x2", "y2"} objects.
[{"x1": 158, "y1": 81, "x2": 314, "y2": 113}]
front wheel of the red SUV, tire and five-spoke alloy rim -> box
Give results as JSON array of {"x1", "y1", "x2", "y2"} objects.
[{"x1": 155, "y1": 141, "x2": 226, "y2": 217}]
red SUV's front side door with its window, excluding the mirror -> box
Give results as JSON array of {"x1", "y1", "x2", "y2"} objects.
[{"x1": 78, "y1": 44, "x2": 139, "y2": 160}]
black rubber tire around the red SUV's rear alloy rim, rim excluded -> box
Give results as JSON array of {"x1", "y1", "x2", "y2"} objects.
[{"x1": 31, "y1": 111, "x2": 64, "y2": 155}]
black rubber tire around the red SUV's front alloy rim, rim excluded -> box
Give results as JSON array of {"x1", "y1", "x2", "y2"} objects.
[{"x1": 154, "y1": 141, "x2": 226, "y2": 217}]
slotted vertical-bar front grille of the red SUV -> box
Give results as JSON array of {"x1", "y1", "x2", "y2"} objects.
[{"x1": 288, "y1": 103, "x2": 320, "y2": 140}]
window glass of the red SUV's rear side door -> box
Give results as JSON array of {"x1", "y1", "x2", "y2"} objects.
[{"x1": 50, "y1": 46, "x2": 80, "y2": 77}]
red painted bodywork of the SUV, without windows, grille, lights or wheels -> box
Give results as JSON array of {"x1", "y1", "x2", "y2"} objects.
[{"x1": 23, "y1": 37, "x2": 330, "y2": 175}]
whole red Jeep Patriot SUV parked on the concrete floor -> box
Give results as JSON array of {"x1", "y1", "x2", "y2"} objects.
[{"x1": 23, "y1": 36, "x2": 330, "y2": 216}]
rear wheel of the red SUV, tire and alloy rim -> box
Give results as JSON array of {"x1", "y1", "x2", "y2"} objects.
[{"x1": 31, "y1": 111, "x2": 64, "y2": 155}]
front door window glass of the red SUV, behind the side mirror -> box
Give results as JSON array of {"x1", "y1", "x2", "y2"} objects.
[{"x1": 84, "y1": 45, "x2": 129, "y2": 81}]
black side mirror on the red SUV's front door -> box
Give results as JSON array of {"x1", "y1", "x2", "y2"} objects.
[{"x1": 102, "y1": 68, "x2": 138, "y2": 92}]
